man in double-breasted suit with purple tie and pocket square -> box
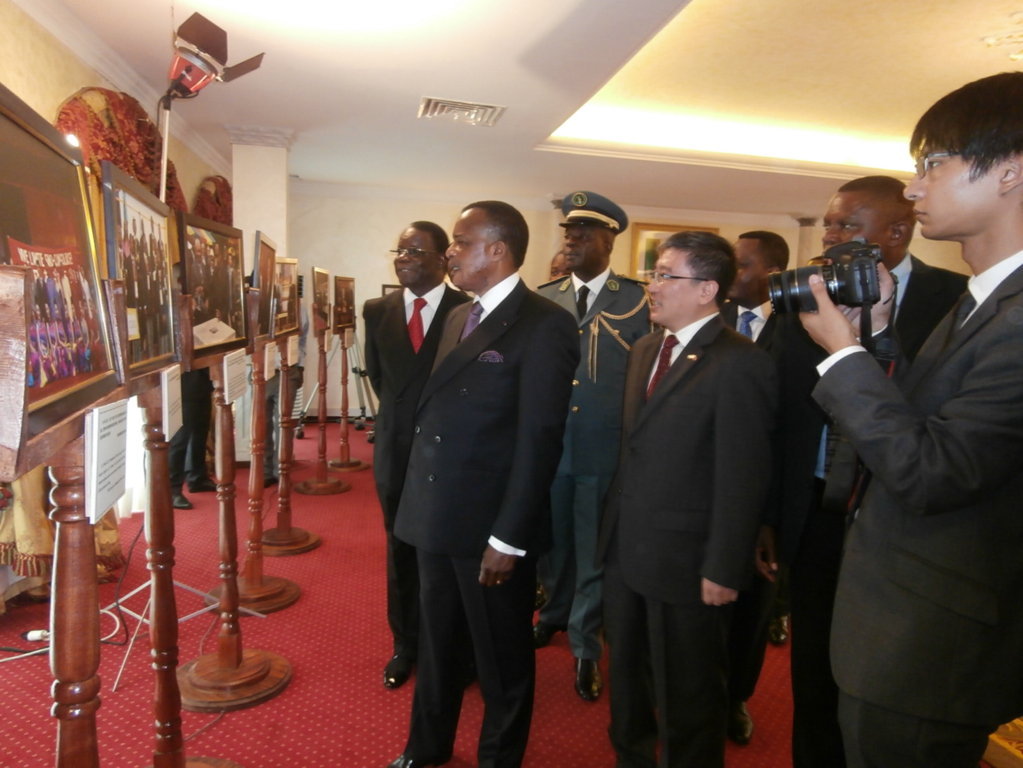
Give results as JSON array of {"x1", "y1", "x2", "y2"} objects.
[{"x1": 391, "y1": 200, "x2": 579, "y2": 768}]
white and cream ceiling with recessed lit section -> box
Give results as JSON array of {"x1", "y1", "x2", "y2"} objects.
[{"x1": 15, "y1": 0, "x2": 1023, "y2": 216}]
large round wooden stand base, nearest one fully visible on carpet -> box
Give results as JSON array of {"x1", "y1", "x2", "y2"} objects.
[{"x1": 178, "y1": 649, "x2": 292, "y2": 712}]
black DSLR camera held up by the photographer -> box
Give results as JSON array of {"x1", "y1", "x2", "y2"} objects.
[{"x1": 767, "y1": 240, "x2": 881, "y2": 312}]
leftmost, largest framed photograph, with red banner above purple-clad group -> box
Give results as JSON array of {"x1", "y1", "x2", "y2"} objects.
[{"x1": 0, "y1": 86, "x2": 118, "y2": 437}]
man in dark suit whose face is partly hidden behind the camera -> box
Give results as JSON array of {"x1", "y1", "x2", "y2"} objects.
[{"x1": 767, "y1": 176, "x2": 966, "y2": 768}]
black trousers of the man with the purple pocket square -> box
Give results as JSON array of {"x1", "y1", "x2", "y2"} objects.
[{"x1": 404, "y1": 550, "x2": 536, "y2": 768}]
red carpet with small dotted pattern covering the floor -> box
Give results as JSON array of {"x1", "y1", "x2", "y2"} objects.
[{"x1": 0, "y1": 425, "x2": 792, "y2": 768}]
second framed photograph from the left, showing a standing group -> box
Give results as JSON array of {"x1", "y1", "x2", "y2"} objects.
[{"x1": 102, "y1": 161, "x2": 177, "y2": 375}]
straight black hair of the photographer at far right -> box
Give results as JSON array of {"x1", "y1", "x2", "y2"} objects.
[{"x1": 909, "y1": 72, "x2": 1023, "y2": 179}]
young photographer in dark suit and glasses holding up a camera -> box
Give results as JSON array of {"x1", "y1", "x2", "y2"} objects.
[{"x1": 793, "y1": 73, "x2": 1023, "y2": 768}]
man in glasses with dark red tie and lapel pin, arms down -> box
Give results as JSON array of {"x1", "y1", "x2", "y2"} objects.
[{"x1": 598, "y1": 232, "x2": 776, "y2": 768}]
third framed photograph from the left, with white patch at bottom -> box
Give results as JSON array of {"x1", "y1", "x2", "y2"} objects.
[{"x1": 178, "y1": 214, "x2": 248, "y2": 357}]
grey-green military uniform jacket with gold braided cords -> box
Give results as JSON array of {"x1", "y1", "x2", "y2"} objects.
[{"x1": 537, "y1": 272, "x2": 650, "y2": 476}]
